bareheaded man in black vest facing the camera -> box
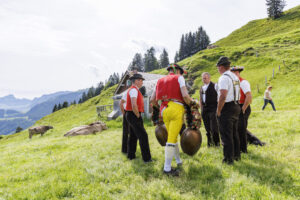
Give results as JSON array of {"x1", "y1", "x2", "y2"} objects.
[{"x1": 200, "y1": 72, "x2": 220, "y2": 147}]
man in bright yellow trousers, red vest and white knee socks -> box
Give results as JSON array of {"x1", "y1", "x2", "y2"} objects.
[{"x1": 151, "y1": 64, "x2": 193, "y2": 176}]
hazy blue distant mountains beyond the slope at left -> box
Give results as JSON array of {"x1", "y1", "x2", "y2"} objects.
[{"x1": 0, "y1": 89, "x2": 88, "y2": 135}]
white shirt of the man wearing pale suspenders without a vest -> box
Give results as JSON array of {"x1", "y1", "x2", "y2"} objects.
[{"x1": 218, "y1": 70, "x2": 240, "y2": 102}]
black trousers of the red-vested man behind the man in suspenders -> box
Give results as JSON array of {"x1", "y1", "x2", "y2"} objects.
[{"x1": 238, "y1": 104, "x2": 251, "y2": 153}]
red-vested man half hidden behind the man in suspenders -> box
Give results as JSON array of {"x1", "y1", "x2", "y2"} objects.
[{"x1": 230, "y1": 67, "x2": 252, "y2": 153}]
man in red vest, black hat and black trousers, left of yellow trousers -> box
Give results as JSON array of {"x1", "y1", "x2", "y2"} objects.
[{"x1": 125, "y1": 74, "x2": 152, "y2": 162}]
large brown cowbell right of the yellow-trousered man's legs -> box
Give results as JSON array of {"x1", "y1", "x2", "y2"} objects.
[{"x1": 180, "y1": 128, "x2": 202, "y2": 156}]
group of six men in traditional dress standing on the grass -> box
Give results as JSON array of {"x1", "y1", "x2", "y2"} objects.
[{"x1": 120, "y1": 57, "x2": 264, "y2": 176}]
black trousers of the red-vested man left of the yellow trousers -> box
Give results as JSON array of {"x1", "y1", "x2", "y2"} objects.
[{"x1": 125, "y1": 111, "x2": 151, "y2": 161}]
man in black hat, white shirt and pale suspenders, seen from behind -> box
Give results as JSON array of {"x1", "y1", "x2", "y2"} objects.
[{"x1": 217, "y1": 57, "x2": 241, "y2": 164}]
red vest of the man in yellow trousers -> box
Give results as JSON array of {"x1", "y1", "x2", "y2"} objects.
[{"x1": 156, "y1": 74, "x2": 184, "y2": 103}]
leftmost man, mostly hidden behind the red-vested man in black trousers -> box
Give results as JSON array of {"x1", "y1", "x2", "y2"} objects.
[{"x1": 119, "y1": 91, "x2": 129, "y2": 153}]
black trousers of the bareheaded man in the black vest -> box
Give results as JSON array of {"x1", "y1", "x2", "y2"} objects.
[{"x1": 202, "y1": 107, "x2": 220, "y2": 146}]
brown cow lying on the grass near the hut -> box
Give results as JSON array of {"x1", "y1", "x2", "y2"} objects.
[{"x1": 64, "y1": 121, "x2": 107, "y2": 136}]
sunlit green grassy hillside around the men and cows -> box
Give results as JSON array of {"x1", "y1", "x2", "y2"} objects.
[{"x1": 0, "y1": 6, "x2": 300, "y2": 200}]
